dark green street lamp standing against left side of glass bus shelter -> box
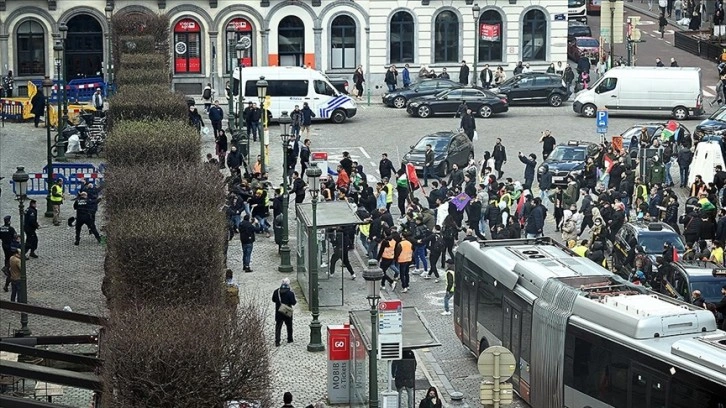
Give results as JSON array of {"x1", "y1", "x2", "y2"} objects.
[{"x1": 305, "y1": 162, "x2": 325, "y2": 352}]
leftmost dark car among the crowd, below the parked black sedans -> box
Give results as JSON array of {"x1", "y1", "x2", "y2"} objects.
[{"x1": 403, "y1": 130, "x2": 474, "y2": 176}]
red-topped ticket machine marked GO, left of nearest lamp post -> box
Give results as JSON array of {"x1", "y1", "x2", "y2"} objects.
[{"x1": 328, "y1": 325, "x2": 350, "y2": 404}]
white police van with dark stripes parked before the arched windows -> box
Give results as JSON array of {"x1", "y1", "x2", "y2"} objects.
[{"x1": 232, "y1": 67, "x2": 358, "y2": 123}]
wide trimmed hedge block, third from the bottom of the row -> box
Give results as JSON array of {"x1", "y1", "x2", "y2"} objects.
[{"x1": 103, "y1": 162, "x2": 225, "y2": 219}]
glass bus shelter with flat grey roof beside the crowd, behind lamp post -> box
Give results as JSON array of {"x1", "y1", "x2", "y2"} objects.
[{"x1": 295, "y1": 201, "x2": 363, "y2": 307}]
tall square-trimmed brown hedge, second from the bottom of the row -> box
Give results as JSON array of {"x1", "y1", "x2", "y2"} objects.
[{"x1": 106, "y1": 207, "x2": 226, "y2": 313}]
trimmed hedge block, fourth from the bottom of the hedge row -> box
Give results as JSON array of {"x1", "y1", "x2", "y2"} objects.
[{"x1": 105, "y1": 119, "x2": 201, "y2": 167}]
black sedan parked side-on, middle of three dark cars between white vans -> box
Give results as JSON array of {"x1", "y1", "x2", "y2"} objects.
[{"x1": 406, "y1": 88, "x2": 509, "y2": 118}]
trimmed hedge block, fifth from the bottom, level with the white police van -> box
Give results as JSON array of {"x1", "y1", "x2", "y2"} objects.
[{"x1": 109, "y1": 85, "x2": 189, "y2": 124}]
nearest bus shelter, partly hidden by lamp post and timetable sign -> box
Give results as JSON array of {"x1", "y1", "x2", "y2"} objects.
[{"x1": 348, "y1": 306, "x2": 441, "y2": 408}]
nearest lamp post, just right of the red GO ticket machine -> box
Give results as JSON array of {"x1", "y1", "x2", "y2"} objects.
[{"x1": 363, "y1": 259, "x2": 383, "y2": 408}]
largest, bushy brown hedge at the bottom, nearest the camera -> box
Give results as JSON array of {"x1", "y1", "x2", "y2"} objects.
[{"x1": 102, "y1": 299, "x2": 273, "y2": 408}]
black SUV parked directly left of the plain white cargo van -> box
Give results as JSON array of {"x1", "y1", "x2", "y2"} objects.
[{"x1": 491, "y1": 72, "x2": 570, "y2": 107}]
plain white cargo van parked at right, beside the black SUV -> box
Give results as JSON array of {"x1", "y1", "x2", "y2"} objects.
[{"x1": 572, "y1": 67, "x2": 704, "y2": 120}]
